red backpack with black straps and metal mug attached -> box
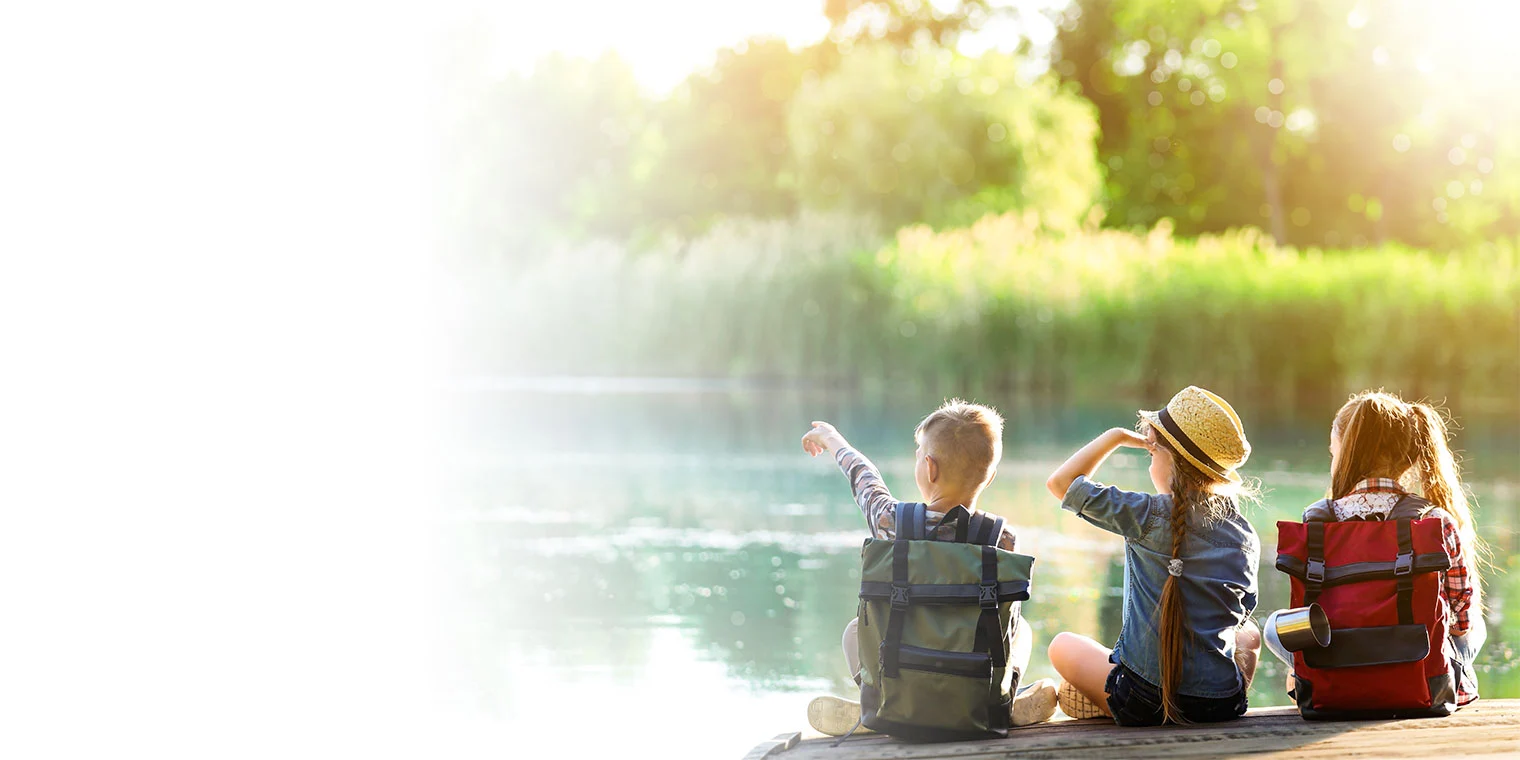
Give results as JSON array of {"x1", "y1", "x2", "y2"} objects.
[{"x1": 1277, "y1": 496, "x2": 1456, "y2": 720}]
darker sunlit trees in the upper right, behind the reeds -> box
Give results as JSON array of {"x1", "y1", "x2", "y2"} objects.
[{"x1": 1053, "y1": 0, "x2": 1520, "y2": 248}]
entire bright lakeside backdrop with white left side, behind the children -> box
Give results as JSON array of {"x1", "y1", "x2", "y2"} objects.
[{"x1": 0, "y1": 0, "x2": 1520, "y2": 757}]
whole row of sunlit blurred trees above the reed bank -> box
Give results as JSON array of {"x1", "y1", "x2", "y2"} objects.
[{"x1": 445, "y1": 0, "x2": 1520, "y2": 263}]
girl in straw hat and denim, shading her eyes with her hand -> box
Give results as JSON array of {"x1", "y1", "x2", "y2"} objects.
[{"x1": 1046, "y1": 386, "x2": 1262, "y2": 725}]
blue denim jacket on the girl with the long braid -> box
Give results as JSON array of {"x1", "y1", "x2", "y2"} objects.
[{"x1": 1061, "y1": 477, "x2": 1262, "y2": 698}]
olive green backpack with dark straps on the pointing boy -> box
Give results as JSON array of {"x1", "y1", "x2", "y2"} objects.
[{"x1": 856, "y1": 503, "x2": 1034, "y2": 742}]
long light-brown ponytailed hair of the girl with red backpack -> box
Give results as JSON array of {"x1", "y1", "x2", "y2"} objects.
[{"x1": 1330, "y1": 391, "x2": 1485, "y2": 613}]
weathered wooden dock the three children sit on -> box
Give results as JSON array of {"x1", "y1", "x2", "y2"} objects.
[{"x1": 745, "y1": 699, "x2": 1520, "y2": 760}]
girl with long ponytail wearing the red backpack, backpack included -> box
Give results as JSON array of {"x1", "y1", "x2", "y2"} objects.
[{"x1": 1265, "y1": 391, "x2": 1487, "y2": 717}]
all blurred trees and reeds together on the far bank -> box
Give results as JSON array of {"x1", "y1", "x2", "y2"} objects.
[{"x1": 441, "y1": 0, "x2": 1520, "y2": 400}]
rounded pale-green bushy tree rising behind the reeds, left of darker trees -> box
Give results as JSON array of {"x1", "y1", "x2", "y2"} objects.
[{"x1": 789, "y1": 46, "x2": 1100, "y2": 230}]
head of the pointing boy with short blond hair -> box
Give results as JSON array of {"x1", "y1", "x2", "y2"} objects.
[{"x1": 914, "y1": 398, "x2": 1003, "y2": 489}]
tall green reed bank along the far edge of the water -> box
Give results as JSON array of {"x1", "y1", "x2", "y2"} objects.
[{"x1": 474, "y1": 216, "x2": 1520, "y2": 401}]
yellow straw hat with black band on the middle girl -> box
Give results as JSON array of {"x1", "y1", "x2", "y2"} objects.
[{"x1": 1140, "y1": 385, "x2": 1251, "y2": 483}]
